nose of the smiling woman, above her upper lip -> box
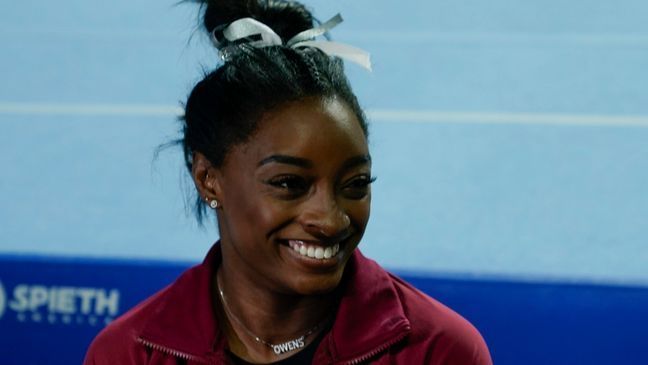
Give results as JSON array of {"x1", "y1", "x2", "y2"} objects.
[{"x1": 299, "y1": 192, "x2": 351, "y2": 243}]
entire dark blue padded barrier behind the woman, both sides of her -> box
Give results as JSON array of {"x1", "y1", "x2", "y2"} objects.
[{"x1": 0, "y1": 255, "x2": 648, "y2": 365}]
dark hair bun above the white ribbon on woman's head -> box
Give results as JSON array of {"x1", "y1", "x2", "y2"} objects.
[{"x1": 198, "y1": 0, "x2": 313, "y2": 41}]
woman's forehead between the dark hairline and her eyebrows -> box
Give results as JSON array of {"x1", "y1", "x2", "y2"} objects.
[{"x1": 235, "y1": 98, "x2": 369, "y2": 161}]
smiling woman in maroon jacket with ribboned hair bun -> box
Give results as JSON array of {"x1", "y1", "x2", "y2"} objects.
[{"x1": 86, "y1": 0, "x2": 491, "y2": 365}]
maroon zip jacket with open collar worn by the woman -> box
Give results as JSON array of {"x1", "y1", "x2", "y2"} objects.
[{"x1": 84, "y1": 244, "x2": 492, "y2": 365}]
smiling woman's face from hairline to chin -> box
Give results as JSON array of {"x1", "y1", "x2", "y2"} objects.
[{"x1": 215, "y1": 98, "x2": 372, "y2": 295}]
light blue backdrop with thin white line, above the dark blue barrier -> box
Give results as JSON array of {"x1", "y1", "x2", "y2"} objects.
[{"x1": 0, "y1": 0, "x2": 648, "y2": 362}]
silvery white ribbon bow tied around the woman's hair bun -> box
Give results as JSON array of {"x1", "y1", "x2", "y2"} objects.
[{"x1": 211, "y1": 14, "x2": 371, "y2": 71}]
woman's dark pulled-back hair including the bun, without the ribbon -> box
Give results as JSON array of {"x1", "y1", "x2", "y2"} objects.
[{"x1": 182, "y1": 0, "x2": 368, "y2": 222}]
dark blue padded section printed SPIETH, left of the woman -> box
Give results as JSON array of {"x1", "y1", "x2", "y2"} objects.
[{"x1": 0, "y1": 255, "x2": 189, "y2": 365}]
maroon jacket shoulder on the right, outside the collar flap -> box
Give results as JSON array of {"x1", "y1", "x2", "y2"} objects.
[{"x1": 389, "y1": 274, "x2": 492, "y2": 365}]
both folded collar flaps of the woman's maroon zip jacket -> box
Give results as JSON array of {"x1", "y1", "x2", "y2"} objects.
[{"x1": 140, "y1": 243, "x2": 410, "y2": 360}]
